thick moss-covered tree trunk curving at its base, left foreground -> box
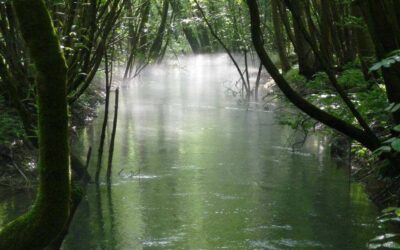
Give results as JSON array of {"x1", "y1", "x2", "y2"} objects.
[{"x1": 0, "y1": 0, "x2": 70, "y2": 250}]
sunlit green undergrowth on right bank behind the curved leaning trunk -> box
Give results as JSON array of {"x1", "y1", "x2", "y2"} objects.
[{"x1": 285, "y1": 63, "x2": 388, "y2": 131}]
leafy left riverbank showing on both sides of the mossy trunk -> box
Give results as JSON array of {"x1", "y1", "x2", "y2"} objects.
[{"x1": 0, "y1": 78, "x2": 105, "y2": 188}]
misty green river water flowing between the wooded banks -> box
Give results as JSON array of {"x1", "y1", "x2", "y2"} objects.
[{"x1": 0, "y1": 55, "x2": 376, "y2": 250}]
